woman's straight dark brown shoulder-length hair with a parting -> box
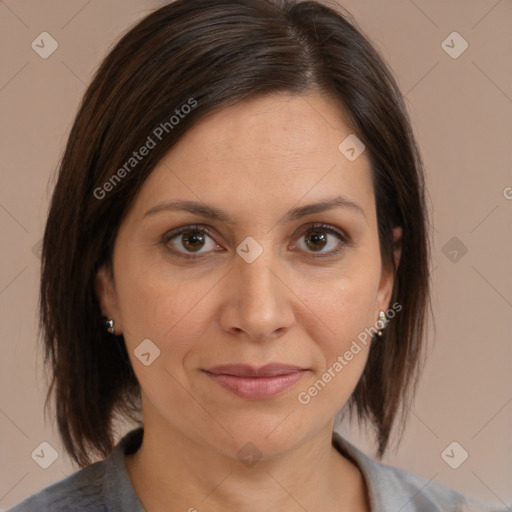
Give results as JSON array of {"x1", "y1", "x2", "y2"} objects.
[{"x1": 40, "y1": 0, "x2": 429, "y2": 467}]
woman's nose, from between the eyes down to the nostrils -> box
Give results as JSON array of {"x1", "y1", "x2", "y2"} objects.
[{"x1": 221, "y1": 247, "x2": 297, "y2": 342}]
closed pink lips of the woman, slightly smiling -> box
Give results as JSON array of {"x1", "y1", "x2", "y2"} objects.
[{"x1": 203, "y1": 363, "x2": 307, "y2": 399}]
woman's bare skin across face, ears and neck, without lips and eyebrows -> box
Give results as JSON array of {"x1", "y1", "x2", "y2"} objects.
[{"x1": 97, "y1": 93, "x2": 401, "y2": 512}]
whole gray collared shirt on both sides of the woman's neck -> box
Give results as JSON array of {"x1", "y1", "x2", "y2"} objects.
[{"x1": 7, "y1": 427, "x2": 512, "y2": 512}]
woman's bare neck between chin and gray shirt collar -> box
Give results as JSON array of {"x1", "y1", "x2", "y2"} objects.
[{"x1": 125, "y1": 424, "x2": 369, "y2": 512}]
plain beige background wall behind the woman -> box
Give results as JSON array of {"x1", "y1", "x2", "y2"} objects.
[{"x1": 0, "y1": 0, "x2": 512, "y2": 509}]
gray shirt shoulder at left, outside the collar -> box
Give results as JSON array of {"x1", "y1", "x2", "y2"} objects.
[{"x1": 7, "y1": 461, "x2": 108, "y2": 512}]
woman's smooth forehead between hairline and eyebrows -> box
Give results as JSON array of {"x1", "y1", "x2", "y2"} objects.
[{"x1": 130, "y1": 93, "x2": 373, "y2": 224}]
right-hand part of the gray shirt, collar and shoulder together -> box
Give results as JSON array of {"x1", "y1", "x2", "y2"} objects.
[{"x1": 333, "y1": 433, "x2": 510, "y2": 512}]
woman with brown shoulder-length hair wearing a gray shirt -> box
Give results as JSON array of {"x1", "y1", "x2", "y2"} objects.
[{"x1": 7, "y1": 0, "x2": 508, "y2": 512}]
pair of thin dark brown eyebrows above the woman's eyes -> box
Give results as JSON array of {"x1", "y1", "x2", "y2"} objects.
[{"x1": 143, "y1": 196, "x2": 366, "y2": 224}]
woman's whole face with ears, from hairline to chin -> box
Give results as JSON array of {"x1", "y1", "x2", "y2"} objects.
[{"x1": 97, "y1": 94, "x2": 399, "y2": 457}]
